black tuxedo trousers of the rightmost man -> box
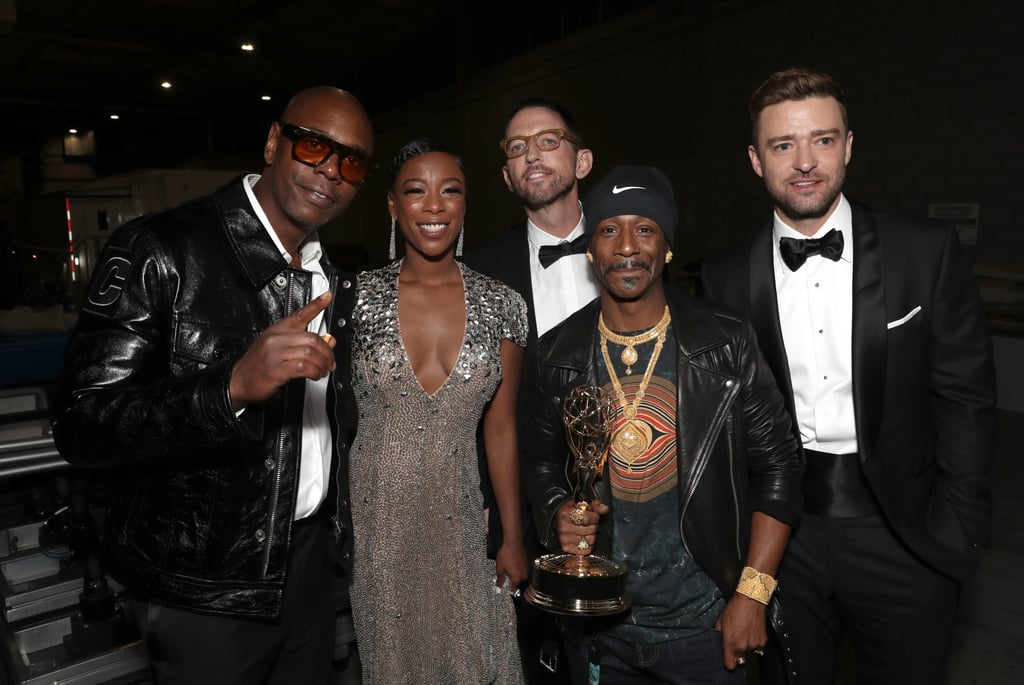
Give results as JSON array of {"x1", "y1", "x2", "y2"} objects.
[{"x1": 761, "y1": 512, "x2": 959, "y2": 685}]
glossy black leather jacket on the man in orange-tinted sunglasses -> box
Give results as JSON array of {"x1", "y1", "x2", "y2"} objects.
[{"x1": 52, "y1": 179, "x2": 355, "y2": 617}]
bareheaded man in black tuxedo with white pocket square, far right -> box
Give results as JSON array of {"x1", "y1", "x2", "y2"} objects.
[{"x1": 701, "y1": 69, "x2": 995, "y2": 685}]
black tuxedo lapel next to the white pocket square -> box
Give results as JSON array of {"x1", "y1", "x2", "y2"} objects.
[{"x1": 850, "y1": 202, "x2": 887, "y2": 461}]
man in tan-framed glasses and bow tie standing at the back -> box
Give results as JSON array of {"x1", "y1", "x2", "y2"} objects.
[{"x1": 466, "y1": 99, "x2": 598, "y2": 685}]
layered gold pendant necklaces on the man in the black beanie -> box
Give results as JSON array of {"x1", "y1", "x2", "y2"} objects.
[{"x1": 597, "y1": 307, "x2": 672, "y2": 473}]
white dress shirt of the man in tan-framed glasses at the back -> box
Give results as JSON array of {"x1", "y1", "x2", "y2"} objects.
[{"x1": 526, "y1": 209, "x2": 598, "y2": 336}]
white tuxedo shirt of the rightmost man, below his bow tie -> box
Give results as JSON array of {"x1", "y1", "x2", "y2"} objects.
[{"x1": 772, "y1": 196, "x2": 857, "y2": 455}]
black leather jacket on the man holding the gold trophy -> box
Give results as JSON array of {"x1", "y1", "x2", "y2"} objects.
[{"x1": 522, "y1": 289, "x2": 803, "y2": 598}]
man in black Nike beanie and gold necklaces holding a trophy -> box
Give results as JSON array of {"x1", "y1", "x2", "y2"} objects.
[{"x1": 522, "y1": 165, "x2": 803, "y2": 685}]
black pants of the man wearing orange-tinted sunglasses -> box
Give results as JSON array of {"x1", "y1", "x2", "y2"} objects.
[{"x1": 135, "y1": 521, "x2": 336, "y2": 685}]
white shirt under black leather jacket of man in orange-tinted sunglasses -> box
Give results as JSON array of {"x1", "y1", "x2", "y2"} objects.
[{"x1": 243, "y1": 174, "x2": 331, "y2": 521}]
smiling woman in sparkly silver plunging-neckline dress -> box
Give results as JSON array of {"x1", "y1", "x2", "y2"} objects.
[{"x1": 349, "y1": 140, "x2": 528, "y2": 685}]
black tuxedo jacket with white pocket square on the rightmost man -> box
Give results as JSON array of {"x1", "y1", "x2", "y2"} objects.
[{"x1": 701, "y1": 201, "x2": 995, "y2": 581}]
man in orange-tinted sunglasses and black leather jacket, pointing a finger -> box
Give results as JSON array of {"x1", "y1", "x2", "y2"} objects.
[{"x1": 52, "y1": 87, "x2": 374, "y2": 685}]
